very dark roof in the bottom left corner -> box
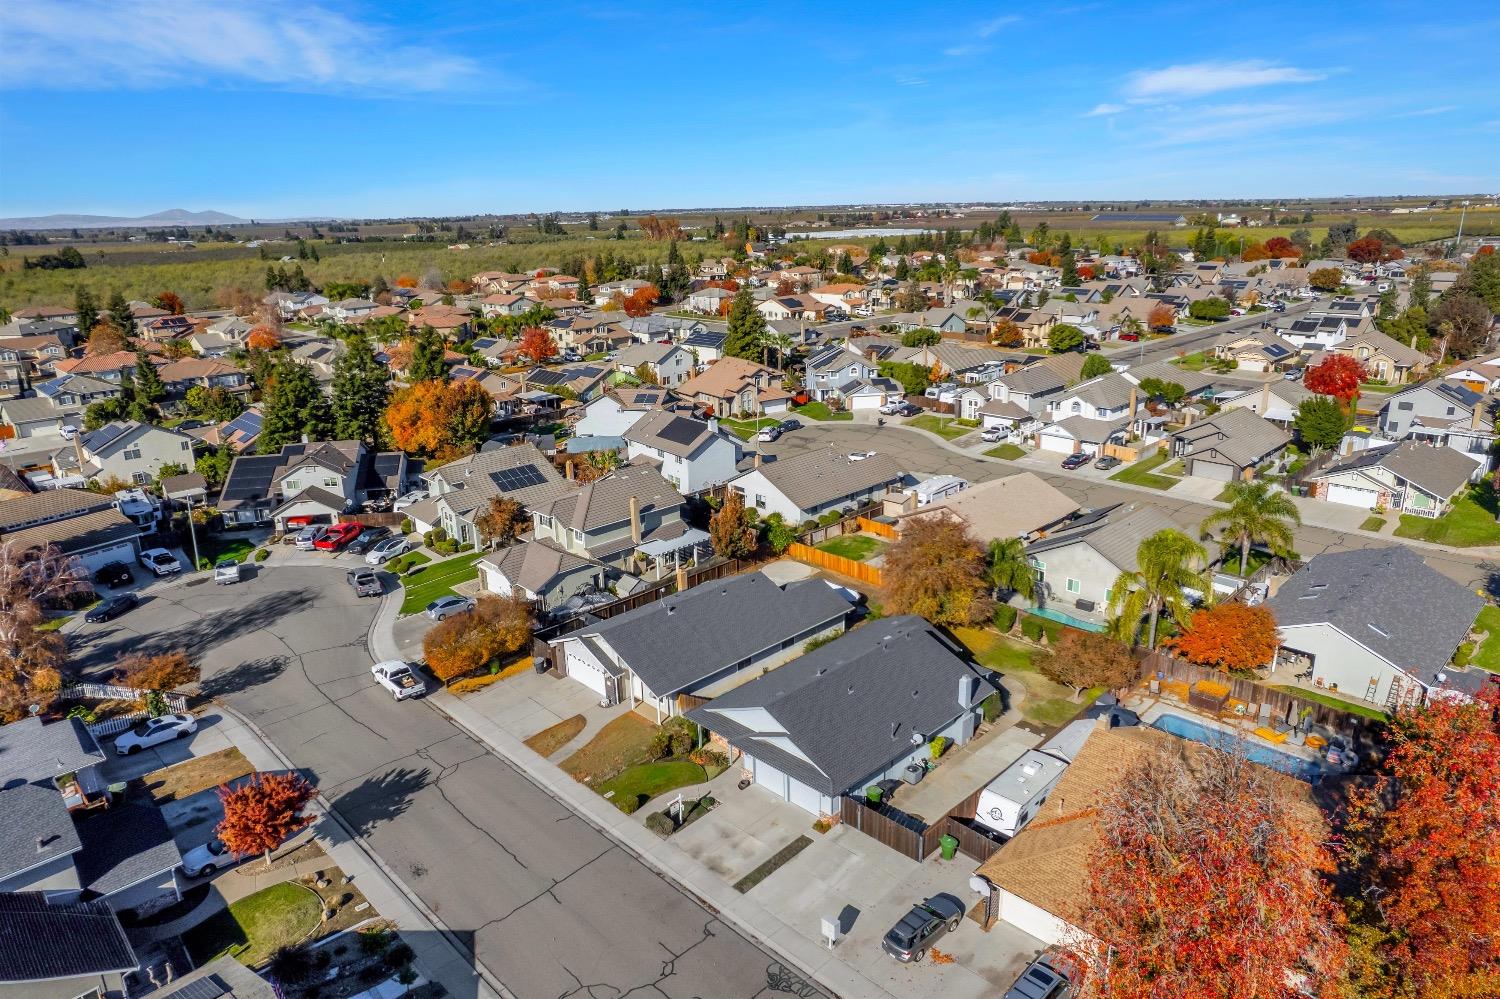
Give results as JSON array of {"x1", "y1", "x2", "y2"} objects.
[{"x1": 0, "y1": 891, "x2": 137, "y2": 983}]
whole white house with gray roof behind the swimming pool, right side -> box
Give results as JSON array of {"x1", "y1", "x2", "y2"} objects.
[{"x1": 1266, "y1": 545, "x2": 1494, "y2": 708}]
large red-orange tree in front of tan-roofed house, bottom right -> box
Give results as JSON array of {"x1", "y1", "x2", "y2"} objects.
[{"x1": 1074, "y1": 743, "x2": 1346, "y2": 999}]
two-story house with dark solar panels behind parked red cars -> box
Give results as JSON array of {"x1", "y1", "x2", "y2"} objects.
[{"x1": 219, "y1": 441, "x2": 407, "y2": 531}]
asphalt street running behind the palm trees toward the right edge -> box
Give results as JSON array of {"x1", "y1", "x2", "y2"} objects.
[{"x1": 761, "y1": 422, "x2": 1500, "y2": 596}]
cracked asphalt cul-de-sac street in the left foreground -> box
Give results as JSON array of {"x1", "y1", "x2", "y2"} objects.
[{"x1": 71, "y1": 566, "x2": 819, "y2": 999}]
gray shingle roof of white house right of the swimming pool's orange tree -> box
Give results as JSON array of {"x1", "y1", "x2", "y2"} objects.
[{"x1": 1266, "y1": 545, "x2": 1485, "y2": 687}]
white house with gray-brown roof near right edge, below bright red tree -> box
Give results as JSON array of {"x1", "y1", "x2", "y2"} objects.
[{"x1": 1313, "y1": 441, "x2": 1484, "y2": 518}]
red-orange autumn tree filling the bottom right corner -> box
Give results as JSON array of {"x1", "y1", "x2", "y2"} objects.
[{"x1": 1350, "y1": 683, "x2": 1500, "y2": 999}]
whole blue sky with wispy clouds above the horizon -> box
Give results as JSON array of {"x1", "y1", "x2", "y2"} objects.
[{"x1": 0, "y1": 0, "x2": 1500, "y2": 218}]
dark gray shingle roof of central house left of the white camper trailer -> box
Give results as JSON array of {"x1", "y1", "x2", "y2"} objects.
[{"x1": 687, "y1": 615, "x2": 995, "y2": 795}]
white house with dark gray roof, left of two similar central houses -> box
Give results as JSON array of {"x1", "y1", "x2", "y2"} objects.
[{"x1": 549, "y1": 573, "x2": 851, "y2": 708}]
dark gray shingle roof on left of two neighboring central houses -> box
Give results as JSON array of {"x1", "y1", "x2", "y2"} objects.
[{"x1": 581, "y1": 573, "x2": 849, "y2": 695}]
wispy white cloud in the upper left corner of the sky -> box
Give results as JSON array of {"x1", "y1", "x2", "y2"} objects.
[{"x1": 0, "y1": 0, "x2": 486, "y2": 96}]
